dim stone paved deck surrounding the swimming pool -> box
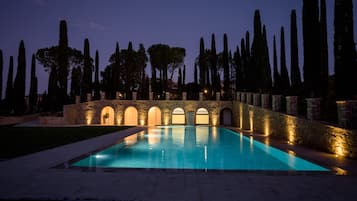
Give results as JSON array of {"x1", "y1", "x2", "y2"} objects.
[{"x1": 0, "y1": 127, "x2": 357, "y2": 201}]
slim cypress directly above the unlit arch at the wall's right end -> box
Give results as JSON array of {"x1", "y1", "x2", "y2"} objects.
[{"x1": 222, "y1": 34, "x2": 231, "y2": 98}]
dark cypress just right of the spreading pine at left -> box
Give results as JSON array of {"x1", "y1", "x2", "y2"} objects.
[{"x1": 81, "y1": 38, "x2": 93, "y2": 101}]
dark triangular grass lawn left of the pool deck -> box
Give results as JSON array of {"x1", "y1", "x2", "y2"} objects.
[{"x1": 0, "y1": 126, "x2": 129, "y2": 159}]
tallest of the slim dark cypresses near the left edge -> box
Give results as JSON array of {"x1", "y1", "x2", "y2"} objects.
[{"x1": 14, "y1": 40, "x2": 26, "y2": 115}]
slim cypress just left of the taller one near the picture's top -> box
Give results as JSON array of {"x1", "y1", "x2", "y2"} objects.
[{"x1": 280, "y1": 27, "x2": 290, "y2": 96}]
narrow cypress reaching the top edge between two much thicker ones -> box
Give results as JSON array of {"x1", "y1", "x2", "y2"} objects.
[{"x1": 320, "y1": 0, "x2": 328, "y2": 98}]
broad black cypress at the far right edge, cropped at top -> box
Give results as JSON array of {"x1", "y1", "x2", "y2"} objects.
[{"x1": 334, "y1": 0, "x2": 357, "y2": 100}]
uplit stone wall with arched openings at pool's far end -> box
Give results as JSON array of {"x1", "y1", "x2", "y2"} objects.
[{"x1": 64, "y1": 100, "x2": 233, "y2": 125}]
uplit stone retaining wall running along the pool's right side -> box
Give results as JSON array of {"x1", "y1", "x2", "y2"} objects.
[{"x1": 233, "y1": 102, "x2": 357, "y2": 158}]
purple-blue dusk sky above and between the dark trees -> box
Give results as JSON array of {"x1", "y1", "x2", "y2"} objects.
[{"x1": 0, "y1": 0, "x2": 357, "y2": 94}]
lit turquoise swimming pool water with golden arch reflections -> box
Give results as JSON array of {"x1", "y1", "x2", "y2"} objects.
[{"x1": 72, "y1": 126, "x2": 328, "y2": 171}]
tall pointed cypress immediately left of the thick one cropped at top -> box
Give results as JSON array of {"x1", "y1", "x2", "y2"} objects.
[{"x1": 290, "y1": 10, "x2": 301, "y2": 95}]
